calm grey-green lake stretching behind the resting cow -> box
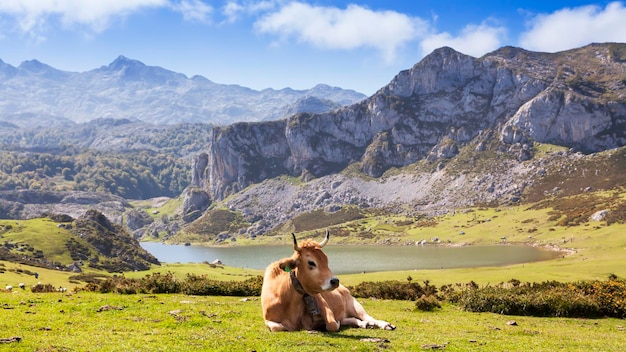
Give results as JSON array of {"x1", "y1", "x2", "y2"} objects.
[{"x1": 141, "y1": 242, "x2": 561, "y2": 274}]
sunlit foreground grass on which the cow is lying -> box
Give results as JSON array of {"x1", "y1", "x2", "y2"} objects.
[{"x1": 0, "y1": 291, "x2": 626, "y2": 351}]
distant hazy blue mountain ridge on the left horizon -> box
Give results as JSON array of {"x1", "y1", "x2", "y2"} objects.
[{"x1": 0, "y1": 56, "x2": 365, "y2": 127}]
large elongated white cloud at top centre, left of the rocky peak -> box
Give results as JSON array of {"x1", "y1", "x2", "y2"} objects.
[{"x1": 255, "y1": 2, "x2": 427, "y2": 62}]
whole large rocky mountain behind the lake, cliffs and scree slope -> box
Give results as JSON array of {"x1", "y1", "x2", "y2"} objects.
[{"x1": 186, "y1": 43, "x2": 626, "y2": 235}]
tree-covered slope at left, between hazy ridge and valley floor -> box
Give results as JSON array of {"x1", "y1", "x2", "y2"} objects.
[{"x1": 0, "y1": 148, "x2": 191, "y2": 199}]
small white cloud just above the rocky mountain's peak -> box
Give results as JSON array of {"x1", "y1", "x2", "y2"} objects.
[{"x1": 420, "y1": 23, "x2": 506, "y2": 57}]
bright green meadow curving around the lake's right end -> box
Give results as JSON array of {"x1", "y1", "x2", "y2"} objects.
[{"x1": 342, "y1": 208, "x2": 626, "y2": 285}]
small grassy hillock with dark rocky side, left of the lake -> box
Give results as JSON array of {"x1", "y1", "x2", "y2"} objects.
[{"x1": 0, "y1": 210, "x2": 159, "y2": 275}]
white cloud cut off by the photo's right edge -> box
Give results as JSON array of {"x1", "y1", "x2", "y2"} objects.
[{"x1": 519, "y1": 2, "x2": 626, "y2": 52}]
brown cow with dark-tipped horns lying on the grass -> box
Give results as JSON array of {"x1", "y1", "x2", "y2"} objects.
[{"x1": 261, "y1": 230, "x2": 396, "y2": 331}]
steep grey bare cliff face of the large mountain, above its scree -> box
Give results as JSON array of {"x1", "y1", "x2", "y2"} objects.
[{"x1": 193, "y1": 44, "x2": 626, "y2": 204}]
